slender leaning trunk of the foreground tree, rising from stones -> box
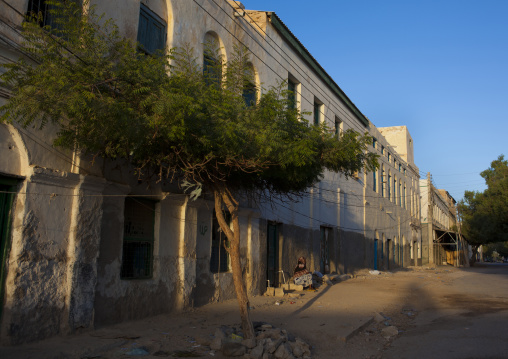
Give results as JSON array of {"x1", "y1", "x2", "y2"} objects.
[{"x1": 214, "y1": 190, "x2": 255, "y2": 339}]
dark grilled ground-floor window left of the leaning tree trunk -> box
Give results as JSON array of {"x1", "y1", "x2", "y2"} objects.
[{"x1": 120, "y1": 198, "x2": 155, "y2": 279}]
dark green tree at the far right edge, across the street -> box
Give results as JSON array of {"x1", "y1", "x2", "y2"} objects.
[{"x1": 458, "y1": 155, "x2": 508, "y2": 264}]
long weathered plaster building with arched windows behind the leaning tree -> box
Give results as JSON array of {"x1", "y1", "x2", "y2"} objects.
[{"x1": 0, "y1": 0, "x2": 423, "y2": 343}]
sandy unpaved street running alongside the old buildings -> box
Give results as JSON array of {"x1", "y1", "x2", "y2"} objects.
[{"x1": 0, "y1": 264, "x2": 508, "y2": 359}]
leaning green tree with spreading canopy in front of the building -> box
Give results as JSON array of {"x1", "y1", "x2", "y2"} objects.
[{"x1": 0, "y1": 1, "x2": 377, "y2": 338}]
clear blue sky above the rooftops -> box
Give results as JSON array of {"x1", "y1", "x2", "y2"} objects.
[{"x1": 242, "y1": 0, "x2": 508, "y2": 201}]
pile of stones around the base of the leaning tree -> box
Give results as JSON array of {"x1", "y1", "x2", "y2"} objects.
[{"x1": 209, "y1": 323, "x2": 312, "y2": 359}]
